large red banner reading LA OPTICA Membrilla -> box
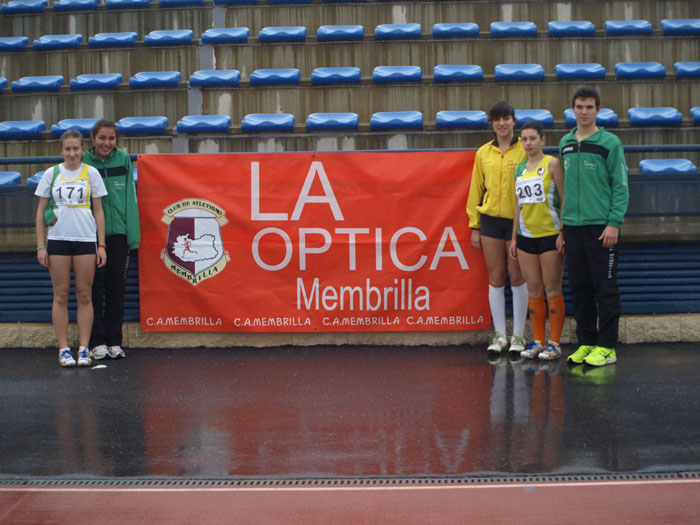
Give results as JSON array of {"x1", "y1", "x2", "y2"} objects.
[{"x1": 138, "y1": 151, "x2": 490, "y2": 332}]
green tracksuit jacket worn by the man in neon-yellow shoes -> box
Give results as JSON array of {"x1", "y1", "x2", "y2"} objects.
[{"x1": 559, "y1": 128, "x2": 629, "y2": 228}]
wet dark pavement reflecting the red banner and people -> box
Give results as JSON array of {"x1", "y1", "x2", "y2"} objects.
[{"x1": 0, "y1": 344, "x2": 700, "y2": 479}]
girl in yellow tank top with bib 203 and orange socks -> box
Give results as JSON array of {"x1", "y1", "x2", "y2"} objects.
[{"x1": 508, "y1": 121, "x2": 565, "y2": 360}]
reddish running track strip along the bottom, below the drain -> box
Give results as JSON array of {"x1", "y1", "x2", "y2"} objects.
[{"x1": 0, "y1": 480, "x2": 700, "y2": 525}]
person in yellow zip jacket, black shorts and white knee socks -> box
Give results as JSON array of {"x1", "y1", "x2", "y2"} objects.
[{"x1": 467, "y1": 101, "x2": 527, "y2": 355}]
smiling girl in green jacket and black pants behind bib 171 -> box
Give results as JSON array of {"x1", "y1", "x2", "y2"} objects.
[{"x1": 83, "y1": 120, "x2": 141, "y2": 359}]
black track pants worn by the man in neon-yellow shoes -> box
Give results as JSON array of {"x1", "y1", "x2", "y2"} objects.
[{"x1": 564, "y1": 225, "x2": 621, "y2": 348}]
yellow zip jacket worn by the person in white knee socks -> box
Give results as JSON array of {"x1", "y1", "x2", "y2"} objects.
[{"x1": 467, "y1": 138, "x2": 527, "y2": 230}]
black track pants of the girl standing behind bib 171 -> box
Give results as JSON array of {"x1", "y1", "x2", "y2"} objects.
[{"x1": 90, "y1": 235, "x2": 129, "y2": 348}]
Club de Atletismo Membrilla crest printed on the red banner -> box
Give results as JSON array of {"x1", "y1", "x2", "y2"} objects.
[{"x1": 160, "y1": 199, "x2": 230, "y2": 286}]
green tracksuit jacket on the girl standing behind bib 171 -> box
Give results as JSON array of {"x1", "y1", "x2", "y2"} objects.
[{"x1": 83, "y1": 148, "x2": 141, "y2": 249}]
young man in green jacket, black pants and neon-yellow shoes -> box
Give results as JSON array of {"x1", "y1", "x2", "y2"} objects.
[{"x1": 559, "y1": 88, "x2": 629, "y2": 366}]
